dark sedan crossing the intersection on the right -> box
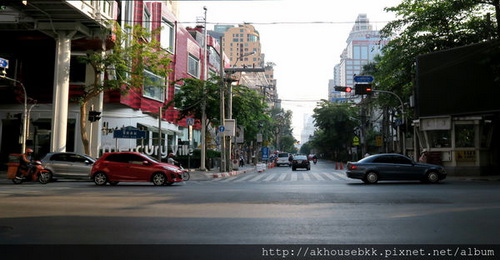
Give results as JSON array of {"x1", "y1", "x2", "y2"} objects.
[{"x1": 346, "y1": 153, "x2": 446, "y2": 183}]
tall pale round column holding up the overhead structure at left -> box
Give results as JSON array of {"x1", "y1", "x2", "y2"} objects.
[{"x1": 50, "y1": 31, "x2": 75, "y2": 152}]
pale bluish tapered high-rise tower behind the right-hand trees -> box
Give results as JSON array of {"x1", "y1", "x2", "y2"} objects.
[{"x1": 329, "y1": 14, "x2": 388, "y2": 101}]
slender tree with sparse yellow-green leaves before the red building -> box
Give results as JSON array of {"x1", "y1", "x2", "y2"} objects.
[{"x1": 78, "y1": 23, "x2": 171, "y2": 154}]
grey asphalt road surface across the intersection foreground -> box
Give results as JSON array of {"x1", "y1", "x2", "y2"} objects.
[{"x1": 0, "y1": 162, "x2": 500, "y2": 250}]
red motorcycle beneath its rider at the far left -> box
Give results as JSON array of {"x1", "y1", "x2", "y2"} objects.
[{"x1": 7, "y1": 154, "x2": 51, "y2": 184}]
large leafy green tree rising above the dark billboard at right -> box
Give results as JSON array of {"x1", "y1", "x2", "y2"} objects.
[{"x1": 374, "y1": 0, "x2": 500, "y2": 106}]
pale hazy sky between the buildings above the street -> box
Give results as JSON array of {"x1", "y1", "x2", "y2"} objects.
[{"x1": 178, "y1": 0, "x2": 401, "y2": 140}]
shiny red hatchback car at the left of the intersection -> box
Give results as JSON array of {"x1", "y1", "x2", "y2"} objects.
[{"x1": 90, "y1": 152, "x2": 182, "y2": 186}]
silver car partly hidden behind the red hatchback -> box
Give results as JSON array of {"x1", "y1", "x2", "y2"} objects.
[{"x1": 41, "y1": 152, "x2": 96, "y2": 180}]
